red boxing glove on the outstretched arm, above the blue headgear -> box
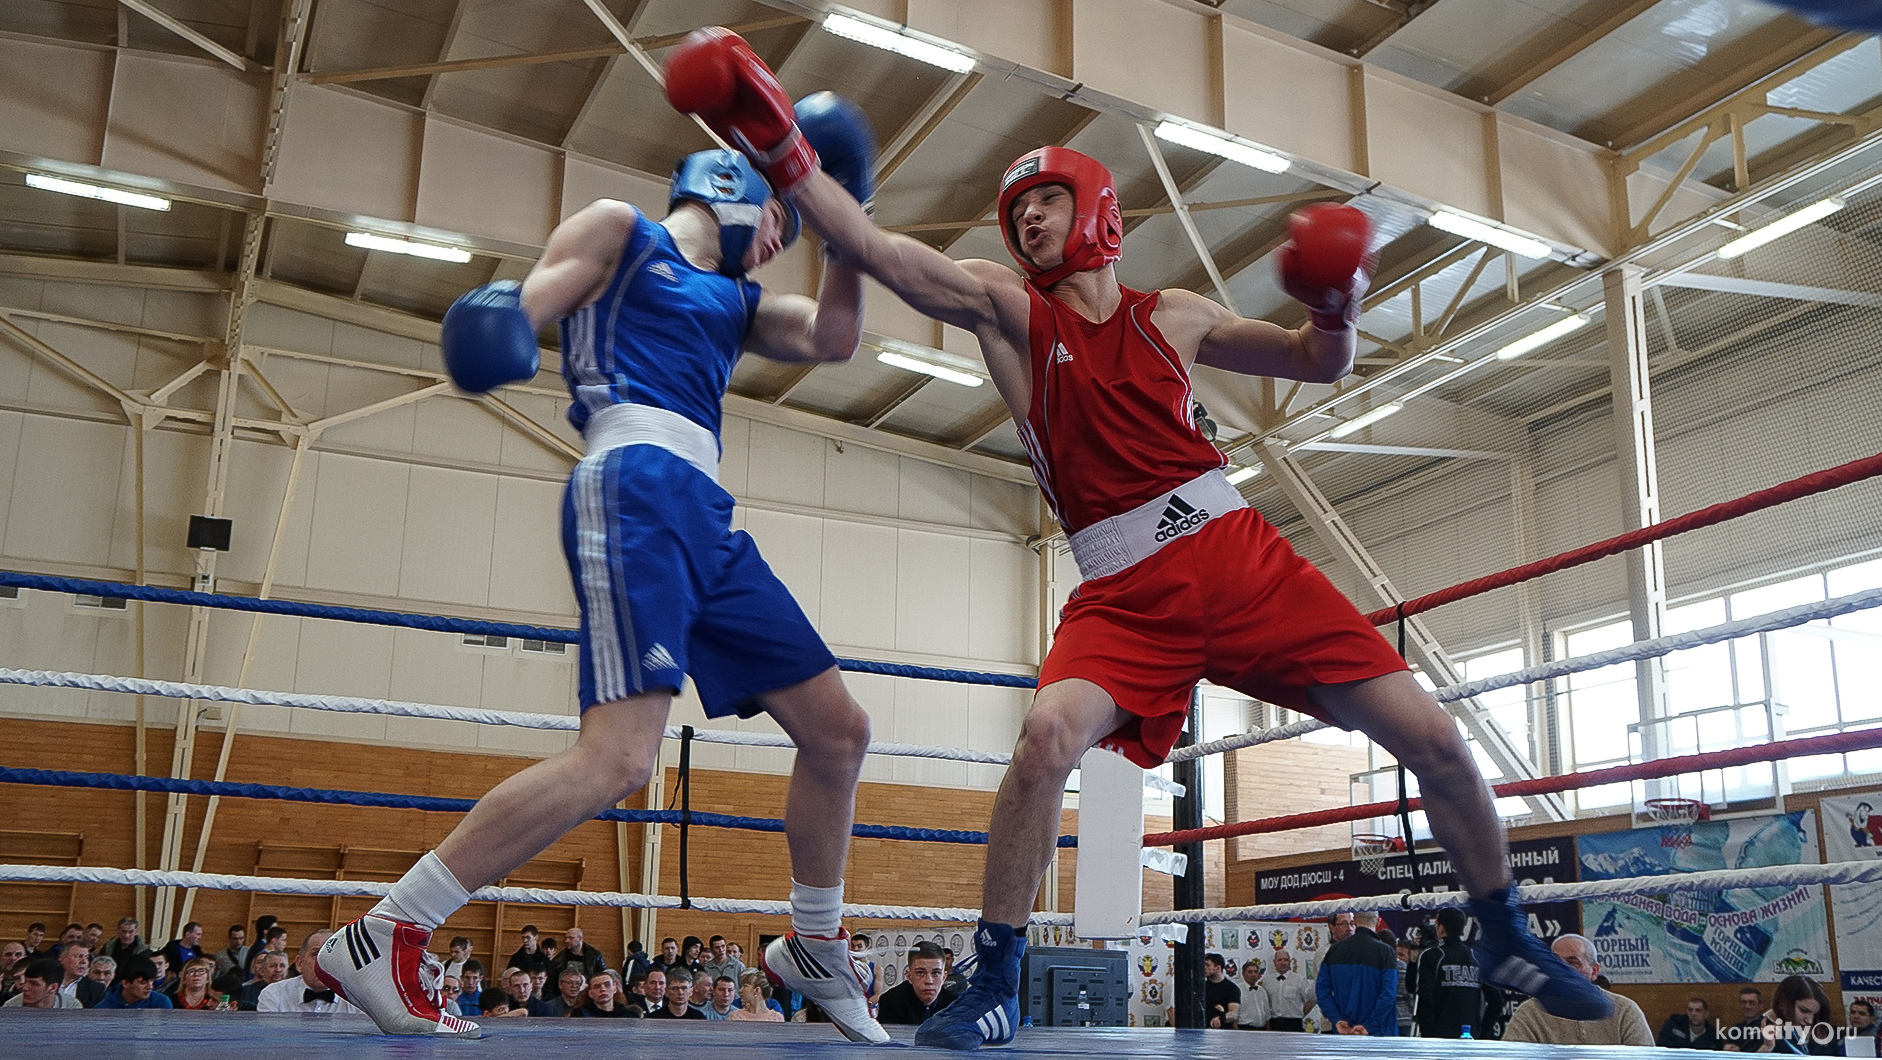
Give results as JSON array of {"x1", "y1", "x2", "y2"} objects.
[{"x1": 666, "y1": 26, "x2": 817, "y2": 194}]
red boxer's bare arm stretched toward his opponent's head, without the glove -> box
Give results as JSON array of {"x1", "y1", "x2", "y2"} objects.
[{"x1": 792, "y1": 171, "x2": 1020, "y2": 333}]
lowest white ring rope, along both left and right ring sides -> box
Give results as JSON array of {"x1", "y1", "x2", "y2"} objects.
[{"x1": 0, "y1": 860, "x2": 1882, "y2": 926}]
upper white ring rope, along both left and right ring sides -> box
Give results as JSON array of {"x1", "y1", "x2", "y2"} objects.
[{"x1": 0, "y1": 589, "x2": 1882, "y2": 775}]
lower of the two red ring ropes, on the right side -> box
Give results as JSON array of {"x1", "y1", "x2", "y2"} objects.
[{"x1": 1144, "y1": 727, "x2": 1882, "y2": 847}]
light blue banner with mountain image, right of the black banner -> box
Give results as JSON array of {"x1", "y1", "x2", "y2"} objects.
[{"x1": 1575, "y1": 810, "x2": 1831, "y2": 983}]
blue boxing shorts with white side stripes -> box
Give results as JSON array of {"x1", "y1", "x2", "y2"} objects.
[{"x1": 563, "y1": 444, "x2": 836, "y2": 717}]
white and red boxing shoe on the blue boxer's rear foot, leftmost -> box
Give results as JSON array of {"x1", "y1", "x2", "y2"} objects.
[{"x1": 314, "y1": 913, "x2": 484, "y2": 1037}]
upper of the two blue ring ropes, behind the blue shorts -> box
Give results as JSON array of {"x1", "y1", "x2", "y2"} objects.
[{"x1": 0, "y1": 570, "x2": 1039, "y2": 689}]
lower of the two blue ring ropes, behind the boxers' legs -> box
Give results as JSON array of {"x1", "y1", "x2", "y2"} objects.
[{"x1": 0, "y1": 768, "x2": 1078, "y2": 847}]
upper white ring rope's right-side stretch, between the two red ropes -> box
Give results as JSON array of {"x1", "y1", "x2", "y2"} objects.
[{"x1": 1169, "y1": 589, "x2": 1882, "y2": 763}]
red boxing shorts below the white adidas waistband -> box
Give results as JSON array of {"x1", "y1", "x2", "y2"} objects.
[{"x1": 1039, "y1": 508, "x2": 1408, "y2": 768}]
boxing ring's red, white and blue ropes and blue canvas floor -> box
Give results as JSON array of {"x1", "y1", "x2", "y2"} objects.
[{"x1": 0, "y1": 456, "x2": 1882, "y2": 1060}]
